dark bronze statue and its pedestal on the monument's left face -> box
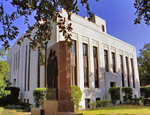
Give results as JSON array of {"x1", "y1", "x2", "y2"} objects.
[{"x1": 46, "y1": 49, "x2": 58, "y2": 100}]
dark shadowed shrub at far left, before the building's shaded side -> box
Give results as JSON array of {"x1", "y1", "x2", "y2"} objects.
[{"x1": 0, "y1": 87, "x2": 20, "y2": 106}]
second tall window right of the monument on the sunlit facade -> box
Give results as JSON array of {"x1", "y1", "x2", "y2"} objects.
[{"x1": 83, "y1": 44, "x2": 89, "y2": 87}]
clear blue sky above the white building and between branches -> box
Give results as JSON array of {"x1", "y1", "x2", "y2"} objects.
[{"x1": 0, "y1": 0, "x2": 150, "y2": 55}]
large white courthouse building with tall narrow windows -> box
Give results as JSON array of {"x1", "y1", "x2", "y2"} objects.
[{"x1": 8, "y1": 10, "x2": 140, "y2": 109}]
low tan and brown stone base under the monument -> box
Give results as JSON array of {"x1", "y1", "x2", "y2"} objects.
[{"x1": 31, "y1": 100, "x2": 83, "y2": 115}]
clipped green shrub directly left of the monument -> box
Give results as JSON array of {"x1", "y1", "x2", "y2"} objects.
[{"x1": 33, "y1": 88, "x2": 46, "y2": 107}]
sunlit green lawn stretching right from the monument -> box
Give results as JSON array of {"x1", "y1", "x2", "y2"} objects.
[{"x1": 77, "y1": 105, "x2": 150, "y2": 115}]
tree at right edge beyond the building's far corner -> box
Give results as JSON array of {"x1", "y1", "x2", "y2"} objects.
[{"x1": 138, "y1": 43, "x2": 150, "y2": 86}]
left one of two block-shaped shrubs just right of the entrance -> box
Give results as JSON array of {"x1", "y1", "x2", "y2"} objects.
[{"x1": 109, "y1": 87, "x2": 120, "y2": 105}]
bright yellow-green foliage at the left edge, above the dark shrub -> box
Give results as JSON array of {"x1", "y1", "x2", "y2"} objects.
[{"x1": 0, "y1": 60, "x2": 10, "y2": 98}]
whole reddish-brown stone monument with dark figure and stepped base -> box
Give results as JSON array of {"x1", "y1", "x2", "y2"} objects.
[{"x1": 31, "y1": 41, "x2": 82, "y2": 115}]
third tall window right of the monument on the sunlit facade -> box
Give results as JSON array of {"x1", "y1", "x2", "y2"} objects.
[{"x1": 93, "y1": 47, "x2": 99, "y2": 88}]
